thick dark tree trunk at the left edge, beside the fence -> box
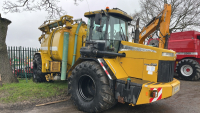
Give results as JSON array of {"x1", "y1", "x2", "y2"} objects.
[{"x1": 0, "y1": 14, "x2": 18, "y2": 83}]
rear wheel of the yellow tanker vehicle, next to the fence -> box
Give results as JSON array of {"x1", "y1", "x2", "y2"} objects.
[{"x1": 33, "y1": 54, "x2": 46, "y2": 82}]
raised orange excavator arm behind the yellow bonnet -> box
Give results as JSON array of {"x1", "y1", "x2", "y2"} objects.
[{"x1": 135, "y1": 4, "x2": 171, "y2": 48}]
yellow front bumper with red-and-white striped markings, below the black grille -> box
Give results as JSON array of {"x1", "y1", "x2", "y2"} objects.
[{"x1": 136, "y1": 79, "x2": 180, "y2": 105}]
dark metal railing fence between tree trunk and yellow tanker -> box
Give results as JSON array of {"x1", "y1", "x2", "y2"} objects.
[{"x1": 7, "y1": 46, "x2": 39, "y2": 78}]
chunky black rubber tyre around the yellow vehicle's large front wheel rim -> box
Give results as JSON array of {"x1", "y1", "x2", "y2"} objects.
[{"x1": 68, "y1": 61, "x2": 117, "y2": 112}]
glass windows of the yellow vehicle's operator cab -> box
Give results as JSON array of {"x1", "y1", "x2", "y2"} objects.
[{"x1": 87, "y1": 16, "x2": 127, "y2": 52}]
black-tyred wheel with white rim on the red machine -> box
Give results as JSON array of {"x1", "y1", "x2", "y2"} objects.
[{"x1": 176, "y1": 59, "x2": 200, "y2": 80}]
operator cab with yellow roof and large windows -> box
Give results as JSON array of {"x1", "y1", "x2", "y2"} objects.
[{"x1": 81, "y1": 7, "x2": 132, "y2": 57}]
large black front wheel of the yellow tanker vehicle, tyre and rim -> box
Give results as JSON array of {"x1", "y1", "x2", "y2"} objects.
[{"x1": 68, "y1": 61, "x2": 117, "y2": 112}]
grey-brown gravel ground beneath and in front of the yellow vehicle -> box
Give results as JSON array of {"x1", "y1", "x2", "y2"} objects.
[{"x1": 0, "y1": 80, "x2": 200, "y2": 113}]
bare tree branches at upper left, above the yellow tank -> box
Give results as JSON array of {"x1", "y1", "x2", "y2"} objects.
[{"x1": 3, "y1": 0, "x2": 83, "y2": 19}]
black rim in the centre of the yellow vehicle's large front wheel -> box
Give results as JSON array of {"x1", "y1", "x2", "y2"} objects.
[{"x1": 78, "y1": 75, "x2": 96, "y2": 101}]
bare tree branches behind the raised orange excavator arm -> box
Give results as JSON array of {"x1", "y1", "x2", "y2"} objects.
[{"x1": 132, "y1": 0, "x2": 200, "y2": 32}]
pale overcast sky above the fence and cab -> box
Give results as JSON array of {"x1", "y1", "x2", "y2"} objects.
[{"x1": 0, "y1": 0, "x2": 140, "y2": 48}]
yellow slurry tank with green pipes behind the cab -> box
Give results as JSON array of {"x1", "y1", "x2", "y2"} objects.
[{"x1": 33, "y1": 15, "x2": 87, "y2": 82}]
